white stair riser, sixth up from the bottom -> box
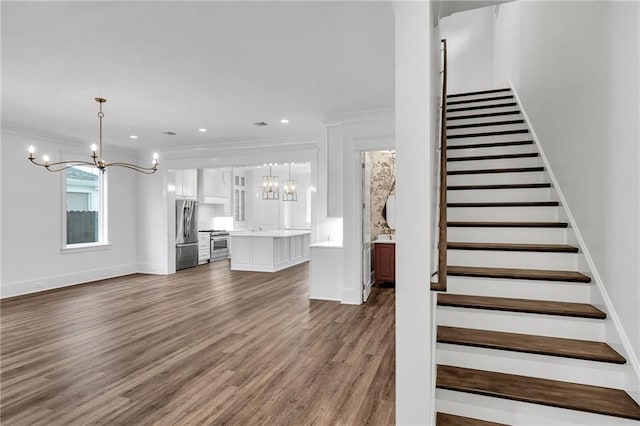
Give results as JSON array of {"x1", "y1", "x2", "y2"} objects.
[{"x1": 447, "y1": 226, "x2": 567, "y2": 244}]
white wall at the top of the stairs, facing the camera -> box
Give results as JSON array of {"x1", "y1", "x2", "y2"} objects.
[{"x1": 440, "y1": 7, "x2": 495, "y2": 93}]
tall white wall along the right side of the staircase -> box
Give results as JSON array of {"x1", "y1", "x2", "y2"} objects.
[{"x1": 496, "y1": 2, "x2": 640, "y2": 366}]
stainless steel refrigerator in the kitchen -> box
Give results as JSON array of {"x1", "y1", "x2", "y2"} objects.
[{"x1": 176, "y1": 200, "x2": 198, "y2": 270}]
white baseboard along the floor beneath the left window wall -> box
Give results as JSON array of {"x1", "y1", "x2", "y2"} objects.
[{"x1": 0, "y1": 263, "x2": 138, "y2": 298}]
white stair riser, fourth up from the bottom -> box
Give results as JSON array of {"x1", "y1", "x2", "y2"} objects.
[{"x1": 447, "y1": 276, "x2": 590, "y2": 303}]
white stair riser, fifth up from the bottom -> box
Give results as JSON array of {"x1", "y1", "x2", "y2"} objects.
[{"x1": 447, "y1": 249, "x2": 578, "y2": 271}]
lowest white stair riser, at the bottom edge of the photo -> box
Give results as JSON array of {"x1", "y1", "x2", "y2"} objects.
[{"x1": 436, "y1": 389, "x2": 638, "y2": 426}]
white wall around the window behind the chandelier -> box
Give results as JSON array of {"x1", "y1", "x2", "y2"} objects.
[{"x1": 0, "y1": 133, "x2": 139, "y2": 297}]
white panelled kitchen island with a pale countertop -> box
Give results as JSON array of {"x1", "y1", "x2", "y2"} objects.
[{"x1": 230, "y1": 230, "x2": 311, "y2": 272}]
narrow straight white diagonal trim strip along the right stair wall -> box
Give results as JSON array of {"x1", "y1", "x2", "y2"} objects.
[{"x1": 509, "y1": 79, "x2": 640, "y2": 403}]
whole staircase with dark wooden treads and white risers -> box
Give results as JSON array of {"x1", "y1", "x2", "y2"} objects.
[{"x1": 436, "y1": 89, "x2": 640, "y2": 426}]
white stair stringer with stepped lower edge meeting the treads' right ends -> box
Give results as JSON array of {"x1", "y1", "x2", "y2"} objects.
[{"x1": 509, "y1": 79, "x2": 640, "y2": 404}]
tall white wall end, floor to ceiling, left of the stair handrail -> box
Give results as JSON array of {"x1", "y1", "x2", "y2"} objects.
[{"x1": 396, "y1": 2, "x2": 439, "y2": 425}]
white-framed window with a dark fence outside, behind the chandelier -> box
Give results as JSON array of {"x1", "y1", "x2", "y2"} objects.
[{"x1": 64, "y1": 166, "x2": 106, "y2": 248}]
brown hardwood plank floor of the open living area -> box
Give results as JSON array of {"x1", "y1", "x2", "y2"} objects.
[{"x1": 0, "y1": 262, "x2": 395, "y2": 426}]
